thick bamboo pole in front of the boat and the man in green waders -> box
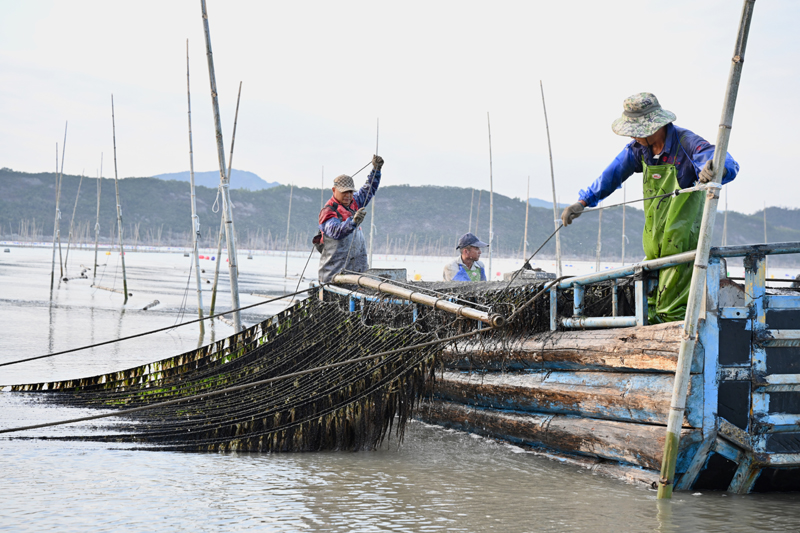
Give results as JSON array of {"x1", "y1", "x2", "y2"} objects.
[{"x1": 658, "y1": 0, "x2": 755, "y2": 499}]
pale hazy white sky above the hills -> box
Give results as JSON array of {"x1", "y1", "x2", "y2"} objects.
[{"x1": 0, "y1": 0, "x2": 800, "y2": 215}]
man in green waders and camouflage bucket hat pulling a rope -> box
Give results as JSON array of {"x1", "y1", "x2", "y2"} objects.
[{"x1": 561, "y1": 93, "x2": 739, "y2": 323}]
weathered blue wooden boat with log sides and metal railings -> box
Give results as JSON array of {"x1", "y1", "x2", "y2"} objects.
[{"x1": 330, "y1": 243, "x2": 800, "y2": 494}]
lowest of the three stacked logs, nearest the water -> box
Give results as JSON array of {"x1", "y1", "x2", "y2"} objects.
[{"x1": 418, "y1": 401, "x2": 702, "y2": 472}]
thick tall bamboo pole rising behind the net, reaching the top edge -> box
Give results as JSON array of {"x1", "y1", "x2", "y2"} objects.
[{"x1": 200, "y1": 0, "x2": 242, "y2": 332}]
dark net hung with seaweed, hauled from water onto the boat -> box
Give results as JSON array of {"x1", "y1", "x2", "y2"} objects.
[{"x1": 6, "y1": 276, "x2": 631, "y2": 452}]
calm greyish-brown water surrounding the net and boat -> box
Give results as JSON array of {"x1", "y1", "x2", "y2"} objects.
[{"x1": 0, "y1": 247, "x2": 800, "y2": 532}]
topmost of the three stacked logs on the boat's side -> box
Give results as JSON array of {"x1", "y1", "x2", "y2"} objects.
[{"x1": 442, "y1": 322, "x2": 703, "y2": 373}]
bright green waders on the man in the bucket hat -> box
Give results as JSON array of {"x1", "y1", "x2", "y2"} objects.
[{"x1": 642, "y1": 141, "x2": 705, "y2": 324}]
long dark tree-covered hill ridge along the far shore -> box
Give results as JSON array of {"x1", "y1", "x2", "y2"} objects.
[{"x1": 0, "y1": 168, "x2": 800, "y2": 266}]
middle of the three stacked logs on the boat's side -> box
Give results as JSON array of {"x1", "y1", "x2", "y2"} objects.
[{"x1": 434, "y1": 371, "x2": 703, "y2": 427}]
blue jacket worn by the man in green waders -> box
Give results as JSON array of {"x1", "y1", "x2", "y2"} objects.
[{"x1": 578, "y1": 124, "x2": 739, "y2": 207}]
